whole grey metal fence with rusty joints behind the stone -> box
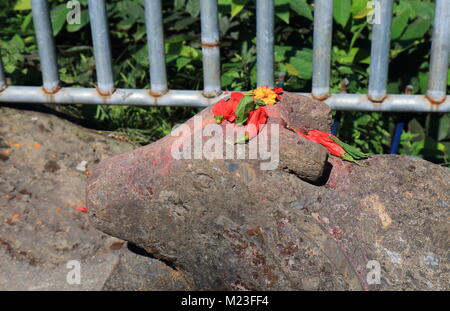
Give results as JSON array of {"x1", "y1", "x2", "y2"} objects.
[{"x1": 0, "y1": 0, "x2": 450, "y2": 112}]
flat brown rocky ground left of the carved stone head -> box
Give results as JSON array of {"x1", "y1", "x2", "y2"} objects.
[{"x1": 0, "y1": 107, "x2": 184, "y2": 290}]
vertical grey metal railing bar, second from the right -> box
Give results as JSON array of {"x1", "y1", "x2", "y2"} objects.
[{"x1": 368, "y1": 0, "x2": 393, "y2": 102}]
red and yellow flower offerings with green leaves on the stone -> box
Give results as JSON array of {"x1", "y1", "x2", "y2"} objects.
[{"x1": 212, "y1": 86, "x2": 367, "y2": 165}]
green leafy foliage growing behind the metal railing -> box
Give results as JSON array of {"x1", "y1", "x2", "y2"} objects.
[{"x1": 0, "y1": 0, "x2": 450, "y2": 163}]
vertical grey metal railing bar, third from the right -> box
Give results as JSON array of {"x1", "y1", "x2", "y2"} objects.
[{"x1": 312, "y1": 0, "x2": 333, "y2": 99}]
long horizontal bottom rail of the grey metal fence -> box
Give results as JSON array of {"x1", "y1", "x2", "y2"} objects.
[{"x1": 0, "y1": 86, "x2": 450, "y2": 112}]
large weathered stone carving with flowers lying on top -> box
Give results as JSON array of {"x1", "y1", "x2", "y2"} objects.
[{"x1": 87, "y1": 94, "x2": 450, "y2": 290}]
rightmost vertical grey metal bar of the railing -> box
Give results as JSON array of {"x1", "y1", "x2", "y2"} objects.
[{"x1": 427, "y1": 0, "x2": 450, "y2": 103}]
